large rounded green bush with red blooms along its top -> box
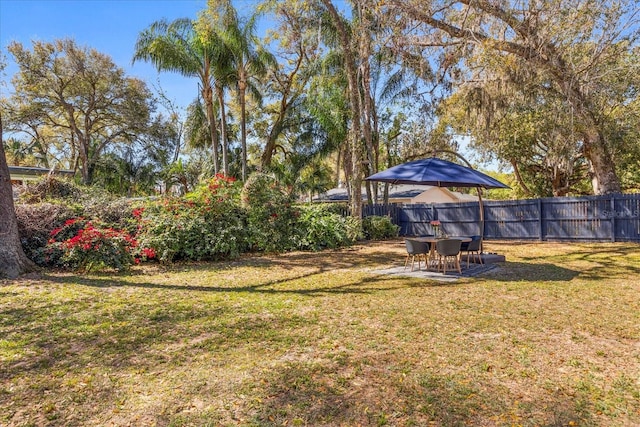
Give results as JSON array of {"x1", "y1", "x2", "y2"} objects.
[{"x1": 135, "y1": 175, "x2": 247, "y2": 262}]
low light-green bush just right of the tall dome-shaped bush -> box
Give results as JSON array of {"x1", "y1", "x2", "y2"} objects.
[{"x1": 299, "y1": 205, "x2": 361, "y2": 251}]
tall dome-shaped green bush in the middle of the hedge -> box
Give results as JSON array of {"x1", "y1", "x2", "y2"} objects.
[{"x1": 242, "y1": 173, "x2": 300, "y2": 252}]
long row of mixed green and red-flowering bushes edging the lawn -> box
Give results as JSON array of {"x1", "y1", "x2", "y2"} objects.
[{"x1": 16, "y1": 174, "x2": 398, "y2": 270}]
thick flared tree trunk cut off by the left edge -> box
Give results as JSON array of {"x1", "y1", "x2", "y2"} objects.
[{"x1": 0, "y1": 114, "x2": 36, "y2": 279}]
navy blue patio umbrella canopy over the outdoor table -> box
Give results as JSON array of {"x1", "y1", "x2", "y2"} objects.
[{"x1": 365, "y1": 157, "x2": 510, "y2": 188}]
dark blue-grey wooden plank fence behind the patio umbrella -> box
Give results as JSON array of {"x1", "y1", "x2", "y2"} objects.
[{"x1": 363, "y1": 194, "x2": 640, "y2": 242}]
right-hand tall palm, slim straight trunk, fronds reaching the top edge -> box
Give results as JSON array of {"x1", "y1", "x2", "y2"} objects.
[{"x1": 209, "y1": 0, "x2": 276, "y2": 181}]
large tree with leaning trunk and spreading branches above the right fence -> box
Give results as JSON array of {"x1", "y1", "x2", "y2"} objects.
[{"x1": 379, "y1": 0, "x2": 639, "y2": 194}]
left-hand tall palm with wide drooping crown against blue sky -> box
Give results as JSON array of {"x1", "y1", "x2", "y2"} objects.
[{"x1": 133, "y1": 18, "x2": 223, "y2": 173}]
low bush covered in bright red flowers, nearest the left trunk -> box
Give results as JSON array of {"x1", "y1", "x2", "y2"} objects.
[{"x1": 42, "y1": 218, "x2": 156, "y2": 271}]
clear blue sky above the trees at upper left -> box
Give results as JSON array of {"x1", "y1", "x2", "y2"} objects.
[{"x1": 0, "y1": 0, "x2": 255, "y2": 107}]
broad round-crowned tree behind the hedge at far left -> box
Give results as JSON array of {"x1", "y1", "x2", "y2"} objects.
[{"x1": 7, "y1": 39, "x2": 152, "y2": 184}]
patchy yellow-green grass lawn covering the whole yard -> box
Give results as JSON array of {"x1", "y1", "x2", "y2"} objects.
[{"x1": 0, "y1": 240, "x2": 640, "y2": 426}]
